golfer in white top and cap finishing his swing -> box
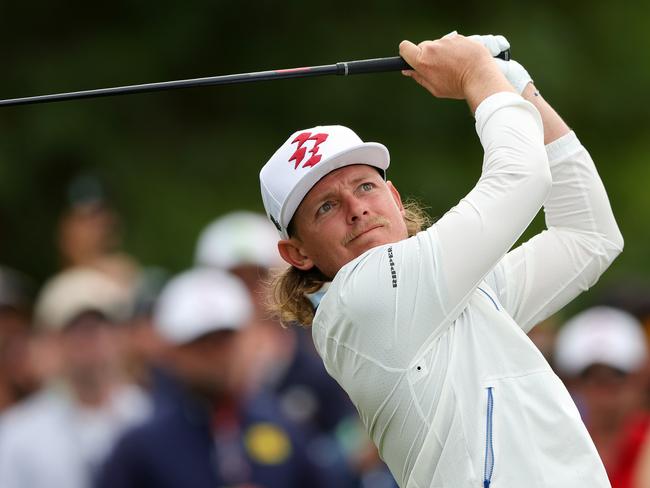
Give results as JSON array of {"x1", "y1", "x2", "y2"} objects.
[{"x1": 260, "y1": 35, "x2": 623, "y2": 488}]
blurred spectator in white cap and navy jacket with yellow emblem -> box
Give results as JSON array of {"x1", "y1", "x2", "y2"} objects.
[{"x1": 99, "y1": 269, "x2": 337, "y2": 488}]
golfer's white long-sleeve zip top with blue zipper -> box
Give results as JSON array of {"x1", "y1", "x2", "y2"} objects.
[{"x1": 313, "y1": 93, "x2": 623, "y2": 488}]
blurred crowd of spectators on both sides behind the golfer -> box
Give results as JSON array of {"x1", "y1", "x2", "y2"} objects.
[{"x1": 0, "y1": 176, "x2": 650, "y2": 488}]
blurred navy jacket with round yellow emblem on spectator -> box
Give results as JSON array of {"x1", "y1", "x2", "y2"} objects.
[{"x1": 97, "y1": 376, "x2": 337, "y2": 488}]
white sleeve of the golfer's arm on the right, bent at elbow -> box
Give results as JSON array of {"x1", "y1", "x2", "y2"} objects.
[{"x1": 486, "y1": 132, "x2": 623, "y2": 332}]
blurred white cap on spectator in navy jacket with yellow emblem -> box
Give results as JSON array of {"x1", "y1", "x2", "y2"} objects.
[{"x1": 154, "y1": 268, "x2": 253, "y2": 345}]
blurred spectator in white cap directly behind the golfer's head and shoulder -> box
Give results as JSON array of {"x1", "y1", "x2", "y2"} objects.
[{"x1": 195, "y1": 211, "x2": 396, "y2": 487}]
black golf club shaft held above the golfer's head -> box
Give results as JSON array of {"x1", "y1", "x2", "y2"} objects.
[{"x1": 0, "y1": 50, "x2": 510, "y2": 106}]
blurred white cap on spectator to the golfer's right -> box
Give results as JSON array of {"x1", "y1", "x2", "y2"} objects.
[{"x1": 555, "y1": 307, "x2": 647, "y2": 376}]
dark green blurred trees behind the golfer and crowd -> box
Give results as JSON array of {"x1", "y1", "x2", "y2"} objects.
[{"x1": 0, "y1": 0, "x2": 650, "y2": 312}]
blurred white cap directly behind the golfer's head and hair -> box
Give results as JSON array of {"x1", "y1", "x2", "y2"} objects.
[{"x1": 195, "y1": 211, "x2": 284, "y2": 269}]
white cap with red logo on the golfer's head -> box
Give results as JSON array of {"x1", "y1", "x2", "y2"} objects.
[{"x1": 260, "y1": 125, "x2": 390, "y2": 239}]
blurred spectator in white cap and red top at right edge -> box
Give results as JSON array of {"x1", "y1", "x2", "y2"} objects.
[{"x1": 555, "y1": 306, "x2": 650, "y2": 488}]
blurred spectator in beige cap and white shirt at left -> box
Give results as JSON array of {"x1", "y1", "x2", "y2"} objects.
[{"x1": 0, "y1": 268, "x2": 148, "y2": 488}]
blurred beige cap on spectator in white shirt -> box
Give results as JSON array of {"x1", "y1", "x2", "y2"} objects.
[{"x1": 34, "y1": 268, "x2": 132, "y2": 330}]
